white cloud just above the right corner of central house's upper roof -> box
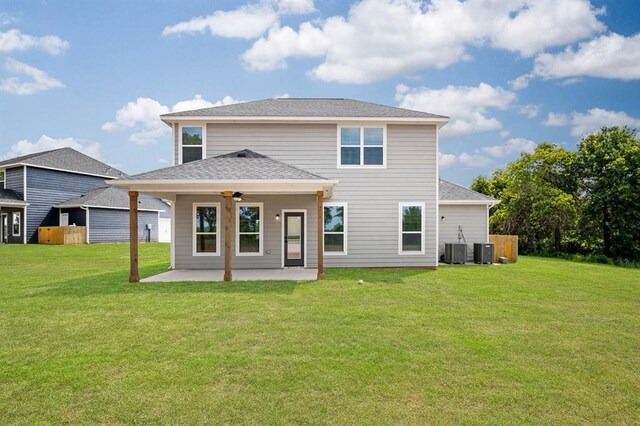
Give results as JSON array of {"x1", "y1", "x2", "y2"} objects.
[{"x1": 396, "y1": 83, "x2": 516, "y2": 135}]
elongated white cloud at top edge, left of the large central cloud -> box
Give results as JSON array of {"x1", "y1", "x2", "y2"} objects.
[{"x1": 162, "y1": 0, "x2": 315, "y2": 39}]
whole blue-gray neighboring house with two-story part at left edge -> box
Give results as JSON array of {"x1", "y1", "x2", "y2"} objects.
[{"x1": 0, "y1": 148, "x2": 171, "y2": 244}]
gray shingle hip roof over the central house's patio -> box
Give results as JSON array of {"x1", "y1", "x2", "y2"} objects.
[{"x1": 119, "y1": 149, "x2": 327, "y2": 181}]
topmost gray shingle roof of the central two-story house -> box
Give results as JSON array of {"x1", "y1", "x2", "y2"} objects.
[{"x1": 160, "y1": 98, "x2": 448, "y2": 122}]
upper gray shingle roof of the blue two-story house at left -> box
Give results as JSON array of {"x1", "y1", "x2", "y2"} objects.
[{"x1": 0, "y1": 148, "x2": 127, "y2": 178}]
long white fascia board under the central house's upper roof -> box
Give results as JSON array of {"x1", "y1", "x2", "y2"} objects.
[{"x1": 160, "y1": 116, "x2": 449, "y2": 127}]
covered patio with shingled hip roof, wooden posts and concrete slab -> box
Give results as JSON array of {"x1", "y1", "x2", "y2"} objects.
[{"x1": 109, "y1": 150, "x2": 338, "y2": 282}]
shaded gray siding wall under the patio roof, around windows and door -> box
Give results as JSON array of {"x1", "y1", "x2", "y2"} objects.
[{"x1": 174, "y1": 195, "x2": 316, "y2": 269}]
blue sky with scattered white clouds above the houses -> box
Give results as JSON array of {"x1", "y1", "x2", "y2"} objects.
[{"x1": 0, "y1": 0, "x2": 640, "y2": 184}]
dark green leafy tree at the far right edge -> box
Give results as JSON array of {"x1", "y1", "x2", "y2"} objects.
[{"x1": 578, "y1": 126, "x2": 640, "y2": 259}]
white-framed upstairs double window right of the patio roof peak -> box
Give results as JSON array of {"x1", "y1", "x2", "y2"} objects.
[{"x1": 338, "y1": 126, "x2": 386, "y2": 167}]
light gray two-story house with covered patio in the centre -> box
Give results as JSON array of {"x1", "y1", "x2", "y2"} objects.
[{"x1": 110, "y1": 98, "x2": 494, "y2": 280}]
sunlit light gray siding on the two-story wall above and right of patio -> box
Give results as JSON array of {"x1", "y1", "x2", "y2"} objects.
[{"x1": 200, "y1": 123, "x2": 438, "y2": 267}]
